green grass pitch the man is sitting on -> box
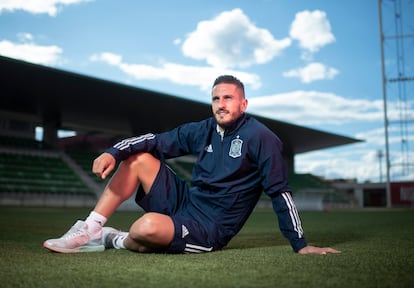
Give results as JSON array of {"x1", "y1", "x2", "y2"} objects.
[{"x1": 0, "y1": 207, "x2": 414, "y2": 288}]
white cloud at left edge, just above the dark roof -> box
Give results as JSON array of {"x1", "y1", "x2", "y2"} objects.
[{"x1": 0, "y1": 33, "x2": 63, "y2": 66}]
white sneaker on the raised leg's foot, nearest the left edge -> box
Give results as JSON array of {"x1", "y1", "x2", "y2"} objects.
[{"x1": 43, "y1": 220, "x2": 105, "y2": 253}]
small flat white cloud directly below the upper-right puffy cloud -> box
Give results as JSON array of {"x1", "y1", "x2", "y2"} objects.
[{"x1": 283, "y1": 62, "x2": 339, "y2": 83}]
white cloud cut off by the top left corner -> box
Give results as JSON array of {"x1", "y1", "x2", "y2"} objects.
[{"x1": 0, "y1": 0, "x2": 93, "y2": 16}]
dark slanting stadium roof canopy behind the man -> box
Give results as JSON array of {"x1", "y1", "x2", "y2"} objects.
[{"x1": 0, "y1": 56, "x2": 360, "y2": 155}]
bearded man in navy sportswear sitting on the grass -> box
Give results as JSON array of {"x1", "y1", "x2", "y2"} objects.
[{"x1": 43, "y1": 75, "x2": 339, "y2": 254}]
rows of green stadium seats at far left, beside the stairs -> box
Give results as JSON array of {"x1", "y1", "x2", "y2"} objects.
[{"x1": 0, "y1": 136, "x2": 96, "y2": 206}]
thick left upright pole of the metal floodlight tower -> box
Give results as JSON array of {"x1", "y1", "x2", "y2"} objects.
[{"x1": 378, "y1": 0, "x2": 392, "y2": 208}]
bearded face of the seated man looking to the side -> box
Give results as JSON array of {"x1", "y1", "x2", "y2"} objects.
[{"x1": 211, "y1": 83, "x2": 247, "y2": 130}]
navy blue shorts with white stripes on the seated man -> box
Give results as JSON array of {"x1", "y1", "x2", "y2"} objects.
[{"x1": 135, "y1": 163, "x2": 222, "y2": 253}]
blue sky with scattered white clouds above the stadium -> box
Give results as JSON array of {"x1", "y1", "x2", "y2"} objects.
[{"x1": 0, "y1": 0, "x2": 414, "y2": 182}]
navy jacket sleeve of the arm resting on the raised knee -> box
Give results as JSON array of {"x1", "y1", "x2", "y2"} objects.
[{"x1": 106, "y1": 122, "x2": 205, "y2": 161}]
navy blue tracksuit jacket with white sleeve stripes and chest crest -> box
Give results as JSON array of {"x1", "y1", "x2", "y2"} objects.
[{"x1": 107, "y1": 114, "x2": 307, "y2": 252}]
